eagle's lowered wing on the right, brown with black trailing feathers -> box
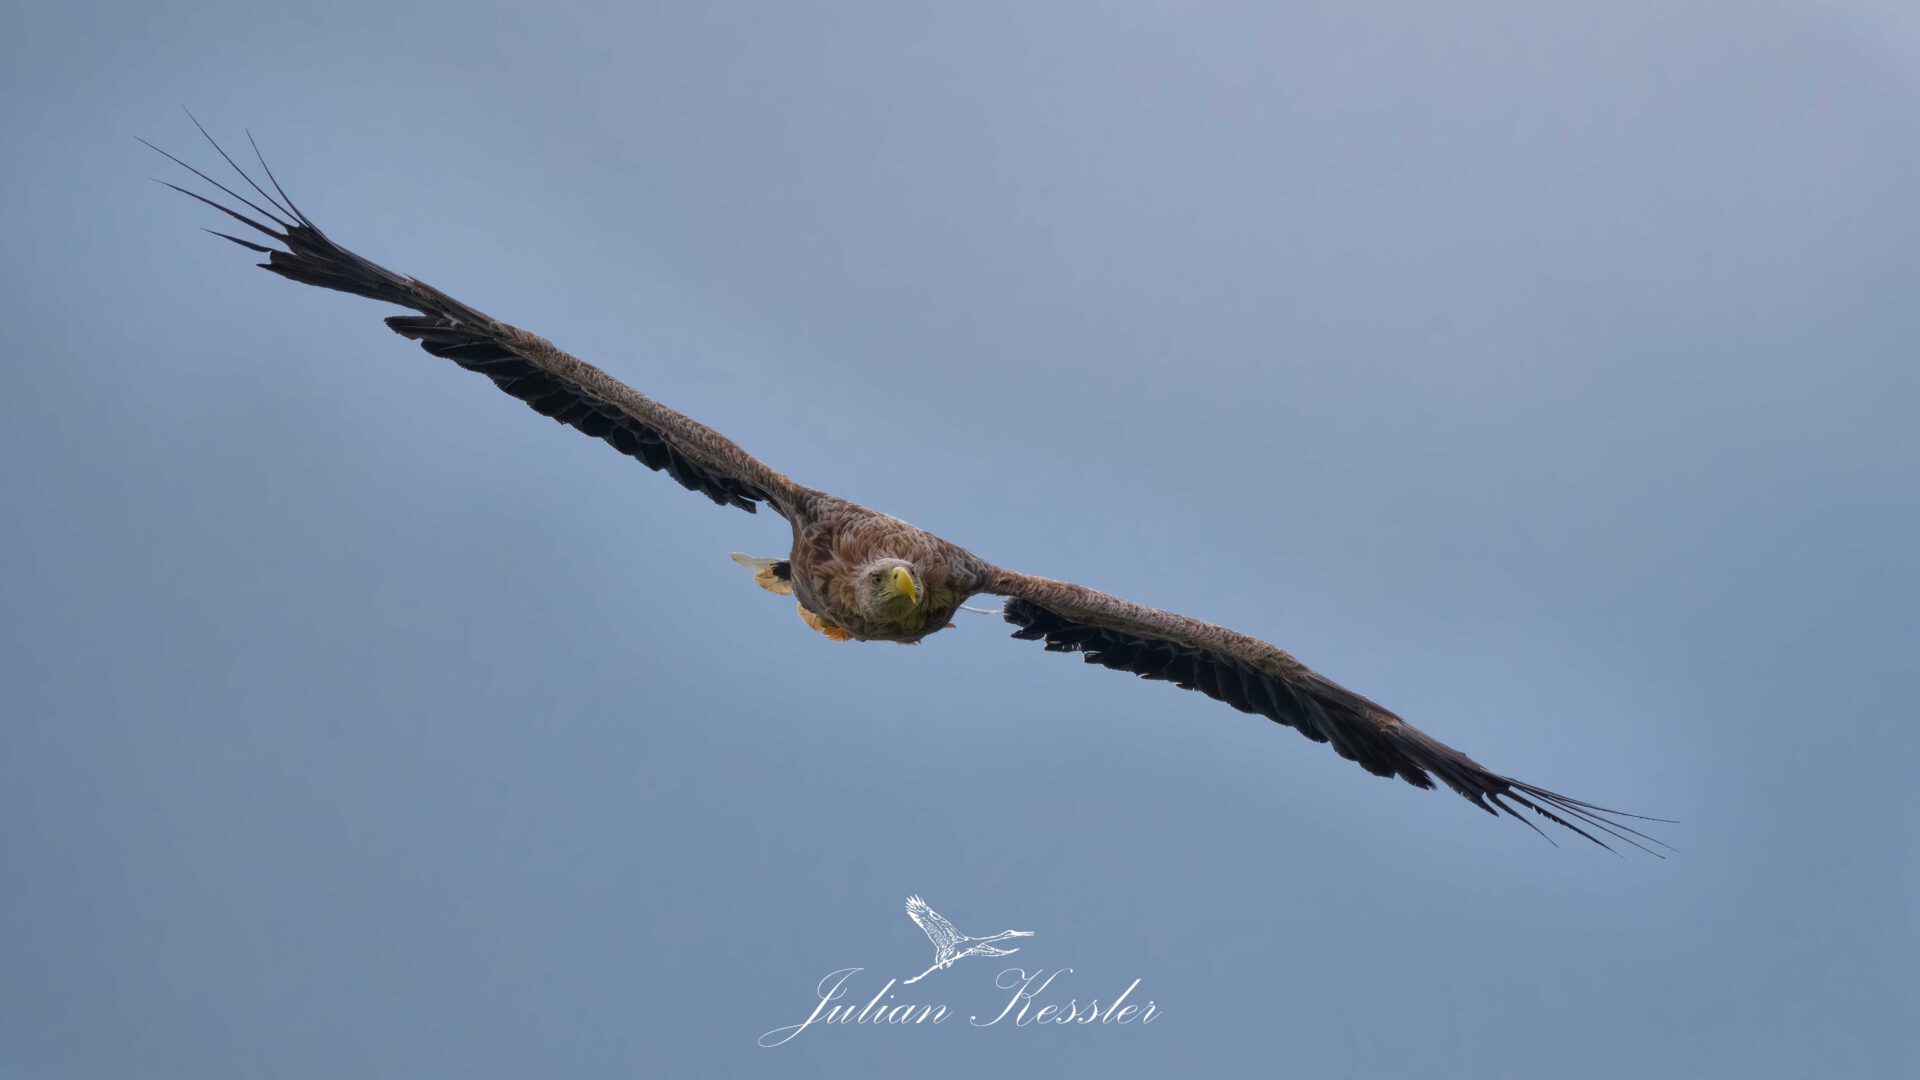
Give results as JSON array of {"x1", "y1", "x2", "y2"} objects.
[{"x1": 981, "y1": 569, "x2": 1667, "y2": 855}]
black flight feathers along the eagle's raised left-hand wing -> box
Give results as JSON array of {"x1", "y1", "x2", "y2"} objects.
[{"x1": 140, "y1": 113, "x2": 768, "y2": 513}]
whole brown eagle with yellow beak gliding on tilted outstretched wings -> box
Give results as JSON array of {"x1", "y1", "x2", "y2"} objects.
[{"x1": 153, "y1": 121, "x2": 1665, "y2": 853}]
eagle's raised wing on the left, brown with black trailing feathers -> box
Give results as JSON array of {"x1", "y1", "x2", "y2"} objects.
[{"x1": 142, "y1": 121, "x2": 810, "y2": 517}]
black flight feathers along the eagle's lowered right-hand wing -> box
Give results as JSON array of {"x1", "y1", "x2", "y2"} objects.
[{"x1": 1004, "y1": 596, "x2": 1667, "y2": 855}]
